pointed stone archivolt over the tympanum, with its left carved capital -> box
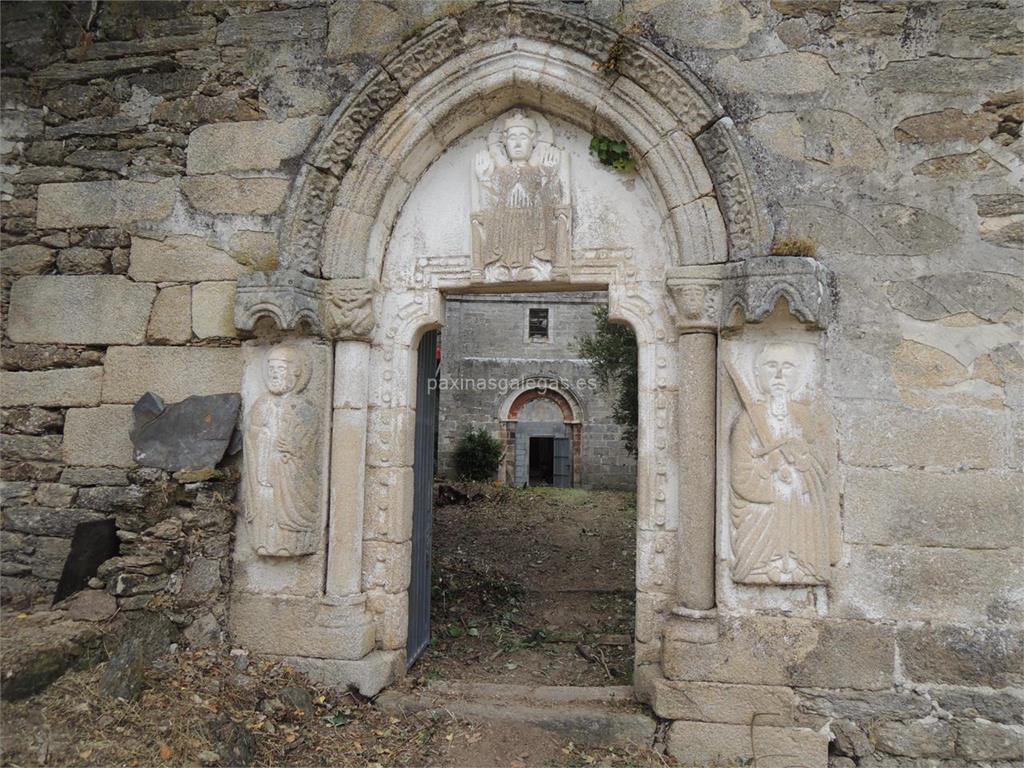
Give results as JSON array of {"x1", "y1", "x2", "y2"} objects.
[{"x1": 236, "y1": 2, "x2": 790, "y2": 338}]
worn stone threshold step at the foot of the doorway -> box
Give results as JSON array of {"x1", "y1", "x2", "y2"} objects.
[{"x1": 376, "y1": 683, "x2": 657, "y2": 748}]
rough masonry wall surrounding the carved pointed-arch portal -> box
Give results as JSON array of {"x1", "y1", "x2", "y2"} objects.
[{"x1": 0, "y1": 0, "x2": 1024, "y2": 768}]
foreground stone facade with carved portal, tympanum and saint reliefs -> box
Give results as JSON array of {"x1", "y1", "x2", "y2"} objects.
[{"x1": 0, "y1": 0, "x2": 1024, "y2": 768}]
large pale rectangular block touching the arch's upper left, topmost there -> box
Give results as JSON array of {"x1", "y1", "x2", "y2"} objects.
[{"x1": 188, "y1": 117, "x2": 321, "y2": 174}]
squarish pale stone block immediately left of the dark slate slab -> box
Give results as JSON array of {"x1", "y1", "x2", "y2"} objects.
[{"x1": 63, "y1": 406, "x2": 135, "y2": 468}]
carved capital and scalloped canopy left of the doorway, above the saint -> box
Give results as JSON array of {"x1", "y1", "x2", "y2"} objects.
[{"x1": 234, "y1": 269, "x2": 376, "y2": 341}]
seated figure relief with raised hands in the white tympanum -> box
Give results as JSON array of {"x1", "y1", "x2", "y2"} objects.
[{"x1": 471, "y1": 110, "x2": 570, "y2": 282}]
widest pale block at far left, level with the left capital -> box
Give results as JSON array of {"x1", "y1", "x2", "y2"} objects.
[{"x1": 7, "y1": 275, "x2": 157, "y2": 344}]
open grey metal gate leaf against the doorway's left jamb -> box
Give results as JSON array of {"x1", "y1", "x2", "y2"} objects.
[{"x1": 406, "y1": 331, "x2": 440, "y2": 667}]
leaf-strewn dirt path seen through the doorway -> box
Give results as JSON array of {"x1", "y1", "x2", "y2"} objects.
[{"x1": 411, "y1": 486, "x2": 636, "y2": 685}]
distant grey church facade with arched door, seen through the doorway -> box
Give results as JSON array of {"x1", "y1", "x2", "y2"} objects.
[{"x1": 437, "y1": 291, "x2": 636, "y2": 488}]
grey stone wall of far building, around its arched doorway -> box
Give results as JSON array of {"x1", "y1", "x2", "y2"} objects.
[{"x1": 437, "y1": 292, "x2": 636, "y2": 488}]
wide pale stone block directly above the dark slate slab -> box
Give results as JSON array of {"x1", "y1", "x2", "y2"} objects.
[{"x1": 103, "y1": 347, "x2": 242, "y2": 402}]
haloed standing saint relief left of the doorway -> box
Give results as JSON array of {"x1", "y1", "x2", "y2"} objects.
[{"x1": 244, "y1": 345, "x2": 321, "y2": 557}]
